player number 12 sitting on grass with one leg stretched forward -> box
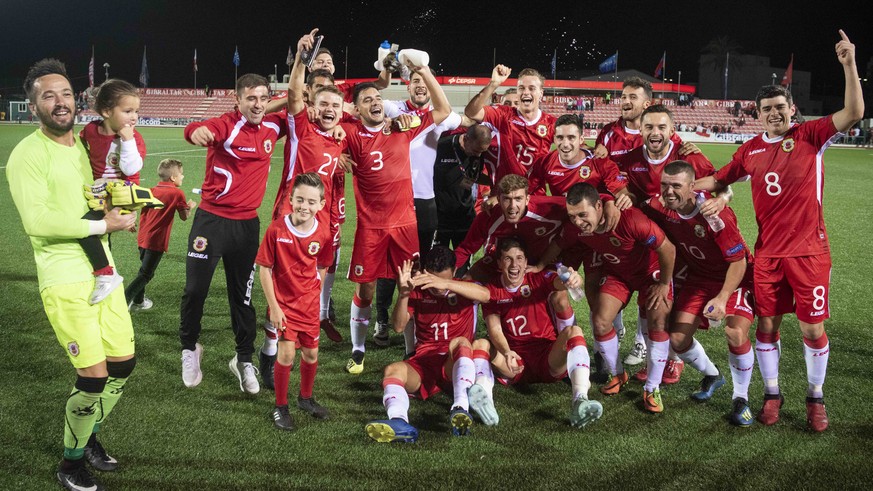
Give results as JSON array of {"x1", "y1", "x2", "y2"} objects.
[{"x1": 482, "y1": 237, "x2": 603, "y2": 428}]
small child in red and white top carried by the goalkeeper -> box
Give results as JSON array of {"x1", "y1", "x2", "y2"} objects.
[{"x1": 79, "y1": 79, "x2": 162, "y2": 304}]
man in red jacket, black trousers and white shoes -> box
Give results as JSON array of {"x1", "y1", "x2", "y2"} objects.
[{"x1": 179, "y1": 74, "x2": 286, "y2": 394}]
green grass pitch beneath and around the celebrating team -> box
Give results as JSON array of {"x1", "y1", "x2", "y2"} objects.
[{"x1": 0, "y1": 125, "x2": 873, "y2": 489}]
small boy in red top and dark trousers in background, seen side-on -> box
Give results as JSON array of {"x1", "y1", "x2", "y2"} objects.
[{"x1": 124, "y1": 159, "x2": 197, "y2": 312}]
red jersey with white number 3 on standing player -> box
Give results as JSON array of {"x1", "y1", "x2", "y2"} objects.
[{"x1": 342, "y1": 113, "x2": 436, "y2": 229}]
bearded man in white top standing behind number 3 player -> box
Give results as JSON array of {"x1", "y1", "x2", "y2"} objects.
[{"x1": 373, "y1": 68, "x2": 461, "y2": 354}]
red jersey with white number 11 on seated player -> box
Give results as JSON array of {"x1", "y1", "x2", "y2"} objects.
[{"x1": 409, "y1": 288, "x2": 477, "y2": 353}]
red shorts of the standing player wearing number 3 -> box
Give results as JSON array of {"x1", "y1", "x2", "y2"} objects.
[{"x1": 348, "y1": 223, "x2": 419, "y2": 283}]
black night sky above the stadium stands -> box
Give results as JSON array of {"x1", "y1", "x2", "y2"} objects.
[{"x1": 0, "y1": 0, "x2": 873, "y2": 101}]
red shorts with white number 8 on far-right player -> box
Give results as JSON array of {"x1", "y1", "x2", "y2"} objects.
[{"x1": 755, "y1": 254, "x2": 831, "y2": 324}]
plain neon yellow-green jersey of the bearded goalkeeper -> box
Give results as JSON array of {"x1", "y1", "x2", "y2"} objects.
[{"x1": 6, "y1": 130, "x2": 112, "y2": 290}]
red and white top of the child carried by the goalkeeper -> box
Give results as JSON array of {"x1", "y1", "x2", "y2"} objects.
[{"x1": 79, "y1": 121, "x2": 146, "y2": 184}]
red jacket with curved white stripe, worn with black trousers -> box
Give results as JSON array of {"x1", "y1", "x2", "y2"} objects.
[{"x1": 185, "y1": 111, "x2": 285, "y2": 220}]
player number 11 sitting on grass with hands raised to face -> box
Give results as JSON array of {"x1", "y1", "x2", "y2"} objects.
[{"x1": 366, "y1": 246, "x2": 499, "y2": 443}]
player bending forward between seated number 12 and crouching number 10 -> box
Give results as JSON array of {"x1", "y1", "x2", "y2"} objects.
[{"x1": 534, "y1": 183, "x2": 675, "y2": 412}]
